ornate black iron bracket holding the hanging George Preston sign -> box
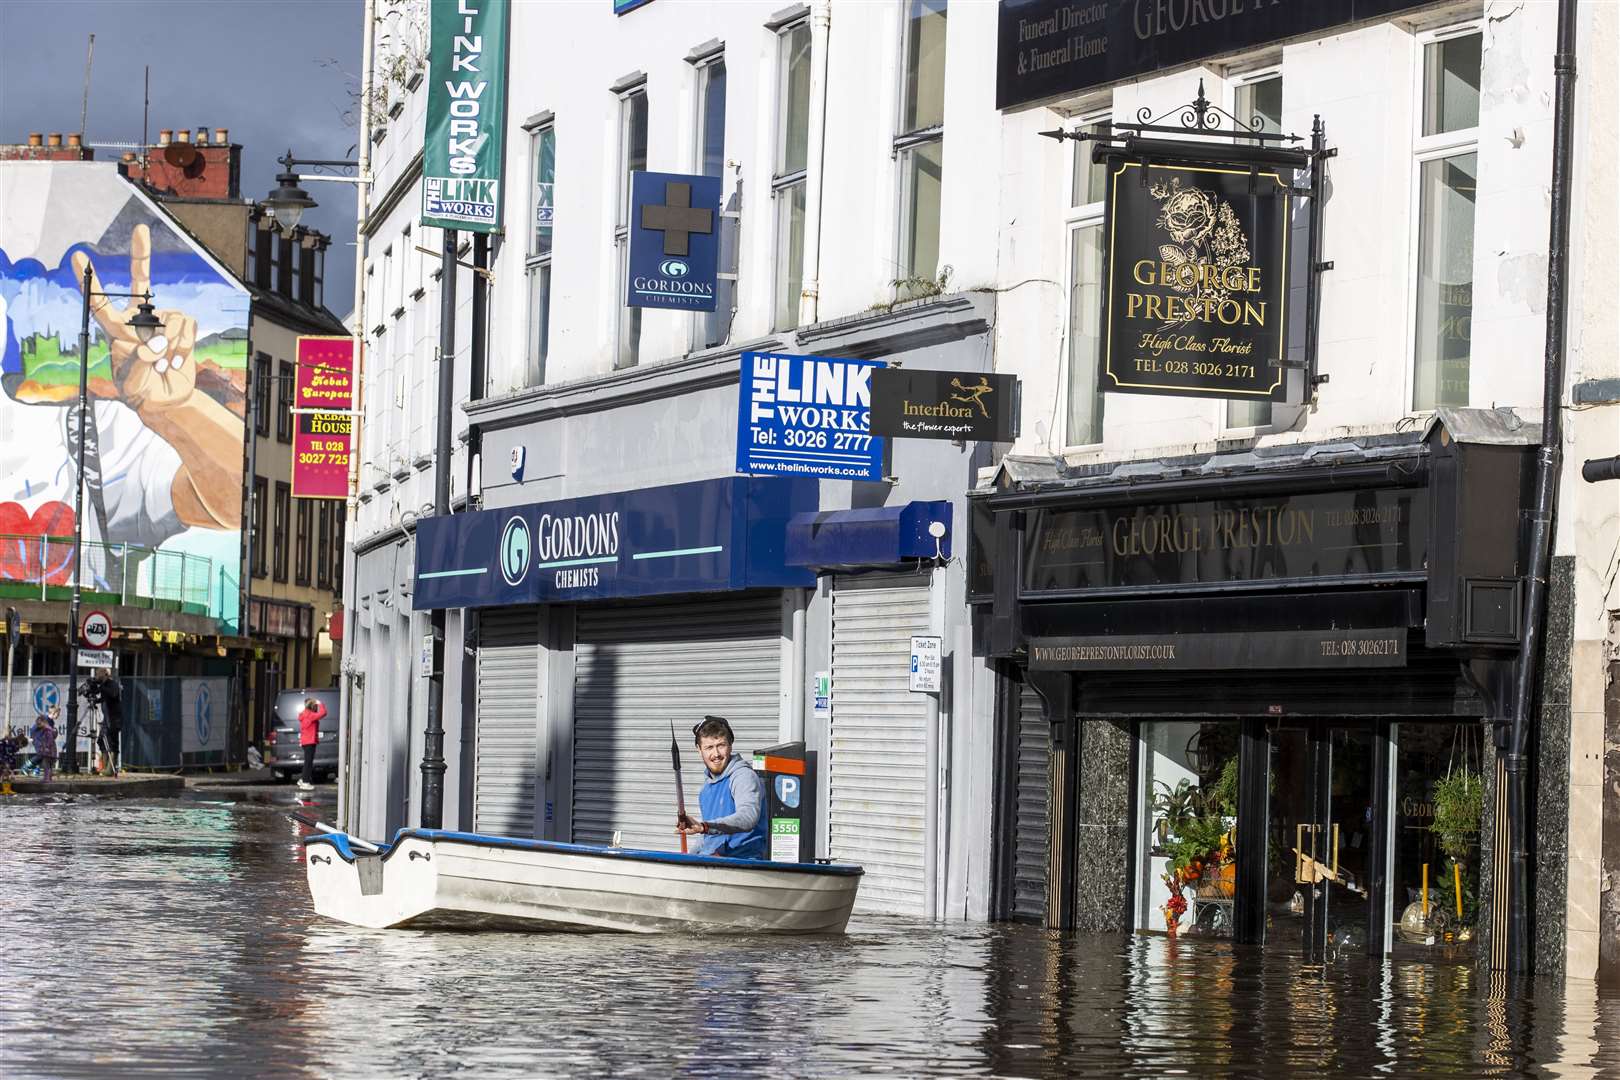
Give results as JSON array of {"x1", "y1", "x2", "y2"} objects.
[{"x1": 1040, "y1": 79, "x2": 1338, "y2": 396}]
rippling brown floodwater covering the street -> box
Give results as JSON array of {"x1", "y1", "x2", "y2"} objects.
[{"x1": 0, "y1": 797, "x2": 1620, "y2": 1078}]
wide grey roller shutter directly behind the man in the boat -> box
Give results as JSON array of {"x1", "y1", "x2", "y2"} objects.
[{"x1": 573, "y1": 593, "x2": 782, "y2": 852}]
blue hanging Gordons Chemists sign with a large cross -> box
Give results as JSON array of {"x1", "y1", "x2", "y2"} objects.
[{"x1": 624, "y1": 172, "x2": 719, "y2": 311}]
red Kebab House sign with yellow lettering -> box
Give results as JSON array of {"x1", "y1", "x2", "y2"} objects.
[{"x1": 293, "y1": 337, "x2": 355, "y2": 499}]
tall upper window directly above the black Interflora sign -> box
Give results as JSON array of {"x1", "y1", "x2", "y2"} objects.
[{"x1": 894, "y1": 0, "x2": 944, "y2": 280}]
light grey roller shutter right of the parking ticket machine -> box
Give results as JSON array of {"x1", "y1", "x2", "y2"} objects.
[{"x1": 828, "y1": 576, "x2": 933, "y2": 915}]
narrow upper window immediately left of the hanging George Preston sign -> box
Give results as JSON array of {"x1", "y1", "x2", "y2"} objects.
[{"x1": 1064, "y1": 115, "x2": 1108, "y2": 447}]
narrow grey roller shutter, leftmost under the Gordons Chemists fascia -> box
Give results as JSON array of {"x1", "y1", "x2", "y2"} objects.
[{"x1": 473, "y1": 607, "x2": 539, "y2": 837}]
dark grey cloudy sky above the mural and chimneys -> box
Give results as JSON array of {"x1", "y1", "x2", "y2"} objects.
[{"x1": 0, "y1": 0, "x2": 365, "y2": 316}]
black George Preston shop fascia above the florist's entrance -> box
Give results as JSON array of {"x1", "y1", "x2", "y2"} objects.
[{"x1": 969, "y1": 410, "x2": 1534, "y2": 939}]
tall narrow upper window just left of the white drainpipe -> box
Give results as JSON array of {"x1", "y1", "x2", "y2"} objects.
[{"x1": 771, "y1": 21, "x2": 810, "y2": 330}]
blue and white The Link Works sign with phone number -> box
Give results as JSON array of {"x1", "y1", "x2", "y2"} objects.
[{"x1": 737, "y1": 353, "x2": 883, "y2": 479}]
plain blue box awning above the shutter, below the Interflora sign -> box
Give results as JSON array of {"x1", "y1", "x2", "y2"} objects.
[{"x1": 786, "y1": 502, "x2": 951, "y2": 570}]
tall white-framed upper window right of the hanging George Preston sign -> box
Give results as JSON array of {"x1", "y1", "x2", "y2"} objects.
[{"x1": 1413, "y1": 28, "x2": 1481, "y2": 411}]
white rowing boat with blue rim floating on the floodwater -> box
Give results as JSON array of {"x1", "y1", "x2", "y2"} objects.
[{"x1": 305, "y1": 829, "x2": 862, "y2": 934}]
